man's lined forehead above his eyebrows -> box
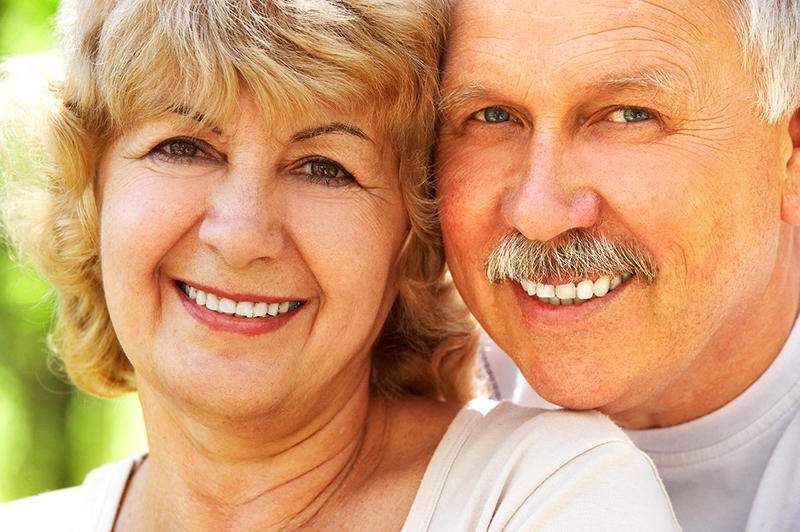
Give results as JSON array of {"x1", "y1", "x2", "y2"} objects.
[{"x1": 443, "y1": 0, "x2": 741, "y2": 108}]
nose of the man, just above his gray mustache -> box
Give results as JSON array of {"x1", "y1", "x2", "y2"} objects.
[{"x1": 502, "y1": 135, "x2": 600, "y2": 242}]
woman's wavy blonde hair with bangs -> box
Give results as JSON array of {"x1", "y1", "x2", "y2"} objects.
[{"x1": 0, "y1": 0, "x2": 477, "y2": 401}]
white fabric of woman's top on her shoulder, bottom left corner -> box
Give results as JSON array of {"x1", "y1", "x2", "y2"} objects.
[{"x1": 0, "y1": 456, "x2": 142, "y2": 532}]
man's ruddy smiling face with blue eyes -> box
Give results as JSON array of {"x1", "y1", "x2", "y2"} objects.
[{"x1": 437, "y1": 0, "x2": 797, "y2": 426}]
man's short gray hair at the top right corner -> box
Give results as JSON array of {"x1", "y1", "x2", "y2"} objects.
[{"x1": 736, "y1": 0, "x2": 800, "y2": 122}]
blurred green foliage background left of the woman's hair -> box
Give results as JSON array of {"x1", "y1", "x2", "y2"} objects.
[{"x1": 0, "y1": 0, "x2": 146, "y2": 502}]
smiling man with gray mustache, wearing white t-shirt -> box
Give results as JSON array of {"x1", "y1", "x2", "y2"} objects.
[{"x1": 436, "y1": 0, "x2": 800, "y2": 532}]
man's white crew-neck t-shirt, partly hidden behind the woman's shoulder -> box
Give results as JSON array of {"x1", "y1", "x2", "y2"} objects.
[{"x1": 481, "y1": 324, "x2": 800, "y2": 532}]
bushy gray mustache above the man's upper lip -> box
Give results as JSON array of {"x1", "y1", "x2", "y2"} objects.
[{"x1": 486, "y1": 229, "x2": 658, "y2": 283}]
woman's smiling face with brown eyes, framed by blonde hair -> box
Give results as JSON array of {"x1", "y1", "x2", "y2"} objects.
[{"x1": 98, "y1": 94, "x2": 408, "y2": 417}]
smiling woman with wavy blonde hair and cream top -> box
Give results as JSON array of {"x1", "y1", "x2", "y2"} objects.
[{"x1": 0, "y1": 0, "x2": 676, "y2": 532}]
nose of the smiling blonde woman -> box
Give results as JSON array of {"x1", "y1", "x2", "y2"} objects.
[{"x1": 200, "y1": 168, "x2": 287, "y2": 268}]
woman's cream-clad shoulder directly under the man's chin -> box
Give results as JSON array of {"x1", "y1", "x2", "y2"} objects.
[{"x1": 408, "y1": 400, "x2": 679, "y2": 531}]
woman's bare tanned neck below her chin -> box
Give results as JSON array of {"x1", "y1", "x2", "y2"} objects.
[{"x1": 115, "y1": 380, "x2": 389, "y2": 531}]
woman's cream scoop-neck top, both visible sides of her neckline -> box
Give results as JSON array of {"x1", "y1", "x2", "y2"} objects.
[{"x1": 0, "y1": 399, "x2": 680, "y2": 532}]
